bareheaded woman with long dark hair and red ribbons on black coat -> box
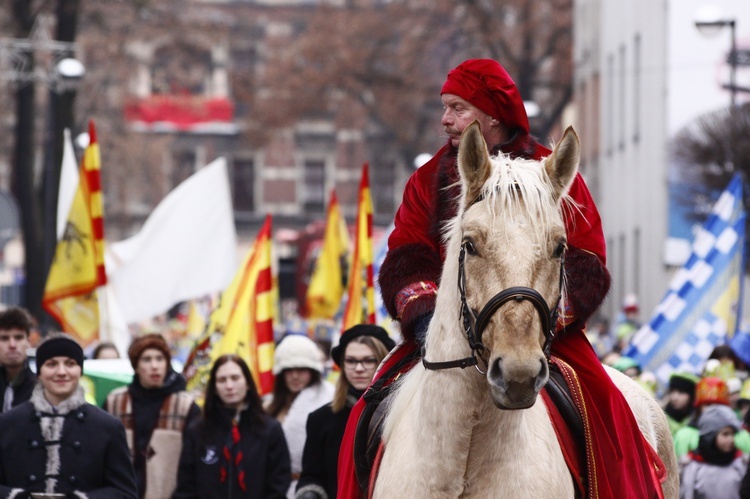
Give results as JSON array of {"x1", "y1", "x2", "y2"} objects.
[{"x1": 172, "y1": 355, "x2": 291, "y2": 499}]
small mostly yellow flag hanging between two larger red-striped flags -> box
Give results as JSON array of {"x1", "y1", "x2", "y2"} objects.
[{"x1": 305, "y1": 190, "x2": 349, "y2": 319}]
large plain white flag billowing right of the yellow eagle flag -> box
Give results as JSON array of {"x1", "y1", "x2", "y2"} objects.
[{"x1": 106, "y1": 158, "x2": 237, "y2": 324}]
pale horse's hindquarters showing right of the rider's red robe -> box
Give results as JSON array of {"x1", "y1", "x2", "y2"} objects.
[{"x1": 606, "y1": 367, "x2": 680, "y2": 499}]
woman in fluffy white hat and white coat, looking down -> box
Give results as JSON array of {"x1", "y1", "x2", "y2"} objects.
[{"x1": 266, "y1": 334, "x2": 333, "y2": 499}]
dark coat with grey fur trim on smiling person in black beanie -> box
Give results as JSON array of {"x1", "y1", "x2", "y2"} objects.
[{"x1": 0, "y1": 385, "x2": 137, "y2": 499}]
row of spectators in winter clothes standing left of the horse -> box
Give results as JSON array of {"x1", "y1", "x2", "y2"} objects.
[{"x1": 0, "y1": 307, "x2": 395, "y2": 499}]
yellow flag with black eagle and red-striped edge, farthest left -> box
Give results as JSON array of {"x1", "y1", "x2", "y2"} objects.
[{"x1": 42, "y1": 121, "x2": 107, "y2": 347}]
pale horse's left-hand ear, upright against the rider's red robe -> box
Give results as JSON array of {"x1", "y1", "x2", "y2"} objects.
[{"x1": 458, "y1": 120, "x2": 491, "y2": 209}]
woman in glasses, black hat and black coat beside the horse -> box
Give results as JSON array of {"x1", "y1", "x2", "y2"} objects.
[{"x1": 296, "y1": 324, "x2": 396, "y2": 499}]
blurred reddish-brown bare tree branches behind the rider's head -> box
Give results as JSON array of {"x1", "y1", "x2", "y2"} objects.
[{"x1": 249, "y1": 0, "x2": 572, "y2": 168}]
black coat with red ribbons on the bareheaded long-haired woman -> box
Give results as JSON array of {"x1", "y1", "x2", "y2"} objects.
[{"x1": 172, "y1": 413, "x2": 292, "y2": 499}]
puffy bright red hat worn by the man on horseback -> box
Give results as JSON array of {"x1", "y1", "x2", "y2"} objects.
[{"x1": 440, "y1": 59, "x2": 529, "y2": 133}]
